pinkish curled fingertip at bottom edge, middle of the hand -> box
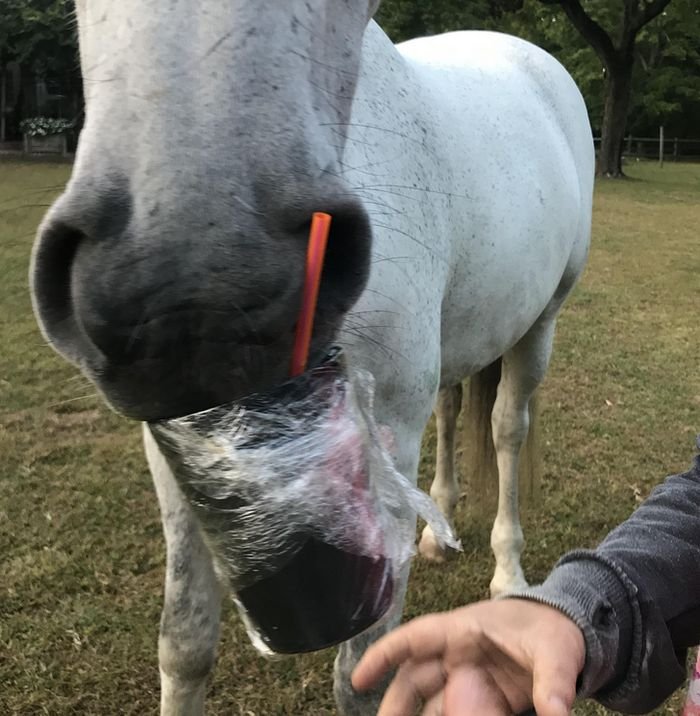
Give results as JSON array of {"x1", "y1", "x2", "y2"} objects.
[{"x1": 440, "y1": 666, "x2": 513, "y2": 716}]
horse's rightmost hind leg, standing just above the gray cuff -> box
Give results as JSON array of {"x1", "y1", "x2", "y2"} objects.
[{"x1": 491, "y1": 317, "x2": 554, "y2": 596}]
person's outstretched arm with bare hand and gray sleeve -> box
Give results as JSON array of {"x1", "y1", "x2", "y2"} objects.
[{"x1": 354, "y1": 440, "x2": 700, "y2": 716}]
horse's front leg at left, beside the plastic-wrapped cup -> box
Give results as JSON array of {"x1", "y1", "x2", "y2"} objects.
[{"x1": 144, "y1": 428, "x2": 222, "y2": 716}]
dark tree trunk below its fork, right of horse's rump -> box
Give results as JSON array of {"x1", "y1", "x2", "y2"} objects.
[{"x1": 598, "y1": 56, "x2": 634, "y2": 177}]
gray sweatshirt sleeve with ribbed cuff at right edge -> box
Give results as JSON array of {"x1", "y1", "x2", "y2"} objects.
[{"x1": 508, "y1": 437, "x2": 700, "y2": 713}]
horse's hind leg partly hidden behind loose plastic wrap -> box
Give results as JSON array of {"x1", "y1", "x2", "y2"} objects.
[{"x1": 418, "y1": 383, "x2": 462, "y2": 562}]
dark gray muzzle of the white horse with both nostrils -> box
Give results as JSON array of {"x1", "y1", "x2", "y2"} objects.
[{"x1": 32, "y1": 182, "x2": 371, "y2": 420}]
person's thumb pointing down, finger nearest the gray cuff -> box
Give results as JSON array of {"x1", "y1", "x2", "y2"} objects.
[{"x1": 532, "y1": 650, "x2": 582, "y2": 716}]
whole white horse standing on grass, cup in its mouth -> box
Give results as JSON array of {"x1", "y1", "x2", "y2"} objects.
[{"x1": 32, "y1": 0, "x2": 594, "y2": 715}]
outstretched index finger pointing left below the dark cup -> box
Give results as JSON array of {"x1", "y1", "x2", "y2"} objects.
[{"x1": 352, "y1": 614, "x2": 447, "y2": 691}]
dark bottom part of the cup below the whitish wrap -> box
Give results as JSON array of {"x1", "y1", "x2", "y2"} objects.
[{"x1": 237, "y1": 537, "x2": 394, "y2": 654}]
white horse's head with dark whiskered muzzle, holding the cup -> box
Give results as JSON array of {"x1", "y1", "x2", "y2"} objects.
[{"x1": 32, "y1": 0, "x2": 378, "y2": 419}]
